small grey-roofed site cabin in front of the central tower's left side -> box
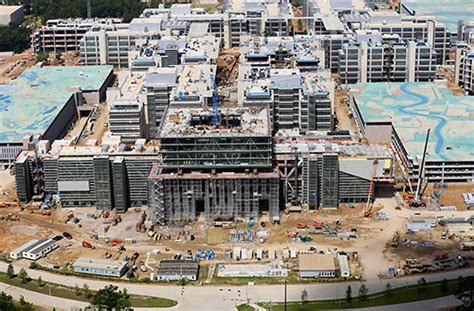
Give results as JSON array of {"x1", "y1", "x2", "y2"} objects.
[{"x1": 156, "y1": 259, "x2": 199, "y2": 281}]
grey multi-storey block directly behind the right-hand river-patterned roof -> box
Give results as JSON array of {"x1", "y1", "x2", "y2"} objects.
[{"x1": 338, "y1": 33, "x2": 437, "y2": 84}]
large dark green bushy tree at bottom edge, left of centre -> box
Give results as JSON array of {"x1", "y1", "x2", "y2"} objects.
[{"x1": 91, "y1": 285, "x2": 130, "y2": 310}]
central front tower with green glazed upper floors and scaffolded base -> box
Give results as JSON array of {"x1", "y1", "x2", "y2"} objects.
[{"x1": 149, "y1": 108, "x2": 280, "y2": 224}]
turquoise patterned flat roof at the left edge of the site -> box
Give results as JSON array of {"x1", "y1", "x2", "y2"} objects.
[{"x1": 0, "y1": 66, "x2": 113, "y2": 142}]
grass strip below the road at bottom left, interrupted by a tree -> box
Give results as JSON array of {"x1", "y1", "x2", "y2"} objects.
[{"x1": 0, "y1": 272, "x2": 177, "y2": 308}]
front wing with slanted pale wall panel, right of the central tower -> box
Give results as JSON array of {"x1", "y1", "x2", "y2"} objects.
[{"x1": 274, "y1": 141, "x2": 392, "y2": 209}]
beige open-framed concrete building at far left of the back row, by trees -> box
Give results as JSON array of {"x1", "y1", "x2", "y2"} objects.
[{"x1": 31, "y1": 18, "x2": 122, "y2": 53}]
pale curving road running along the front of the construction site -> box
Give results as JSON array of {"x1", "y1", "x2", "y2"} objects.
[{"x1": 0, "y1": 262, "x2": 474, "y2": 311}]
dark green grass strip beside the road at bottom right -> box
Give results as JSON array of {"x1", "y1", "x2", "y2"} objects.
[{"x1": 259, "y1": 279, "x2": 459, "y2": 311}]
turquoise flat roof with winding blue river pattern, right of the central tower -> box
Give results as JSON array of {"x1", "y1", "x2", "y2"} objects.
[{"x1": 352, "y1": 82, "x2": 474, "y2": 161}]
